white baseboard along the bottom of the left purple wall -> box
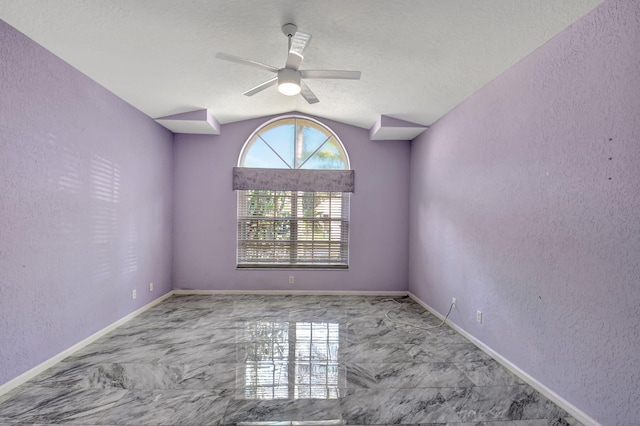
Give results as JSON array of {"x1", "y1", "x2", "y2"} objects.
[{"x1": 0, "y1": 291, "x2": 173, "y2": 396}]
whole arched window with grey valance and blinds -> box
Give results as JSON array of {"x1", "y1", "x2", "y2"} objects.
[{"x1": 234, "y1": 116, "x2": 354, "y2": 269}]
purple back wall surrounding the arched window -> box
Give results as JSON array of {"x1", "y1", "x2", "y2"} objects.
[{"x1": 173, "y1": 118, "x2": 410, "y2": 291}]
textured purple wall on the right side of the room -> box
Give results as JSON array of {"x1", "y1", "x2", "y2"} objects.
[{"x1": 410, "y1": 0, "x2": 640, "y2": 425}]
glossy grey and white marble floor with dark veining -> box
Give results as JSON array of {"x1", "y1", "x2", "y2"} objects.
[{"x1": 0, "y1": 295, "x2": 579, "y2": 426}]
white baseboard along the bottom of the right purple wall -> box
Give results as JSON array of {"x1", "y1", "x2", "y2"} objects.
[{"x1": 408, "y1": 292, "x2": 601, "y2": 426}]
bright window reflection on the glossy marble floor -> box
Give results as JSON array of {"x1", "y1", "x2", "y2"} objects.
[{"x1": 236, "y1": 321, "x2": 346, "y2": 399}]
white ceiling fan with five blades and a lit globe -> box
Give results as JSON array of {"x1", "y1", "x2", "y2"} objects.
[{"x1": 216, "y1": 24, "x2": 361, "y2": 104}]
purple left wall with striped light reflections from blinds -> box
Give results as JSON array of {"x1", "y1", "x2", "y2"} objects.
[{"x1": 0, "y1": 21, "x2": 172, "y2": 384}]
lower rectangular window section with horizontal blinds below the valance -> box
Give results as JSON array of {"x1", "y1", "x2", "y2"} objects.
[{"x1": 238, "y1": 190, "x2": 350, "y2": 269}]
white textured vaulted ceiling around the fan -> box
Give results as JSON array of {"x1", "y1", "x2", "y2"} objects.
[{"x1": 0, "y1": 0, "x2": 602, "y2": 128}]
